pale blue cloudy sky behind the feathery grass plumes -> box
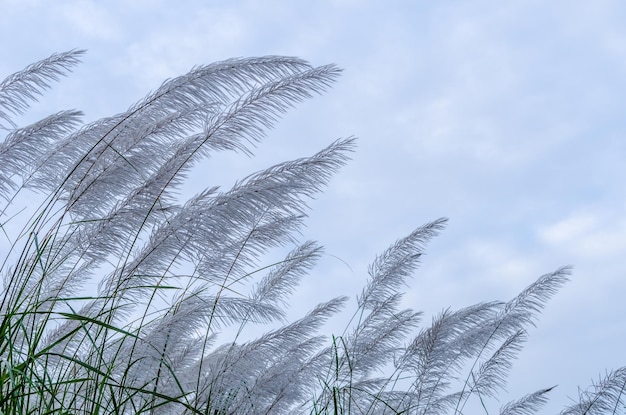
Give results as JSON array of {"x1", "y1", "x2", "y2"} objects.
[{"x1": 0, "y1": 0, "x2": 626, "y2": 413}]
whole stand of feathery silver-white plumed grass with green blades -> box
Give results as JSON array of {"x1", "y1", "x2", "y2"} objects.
[{"x1": 0, "y1": 51, "x2": 626, "y2": 415}]
